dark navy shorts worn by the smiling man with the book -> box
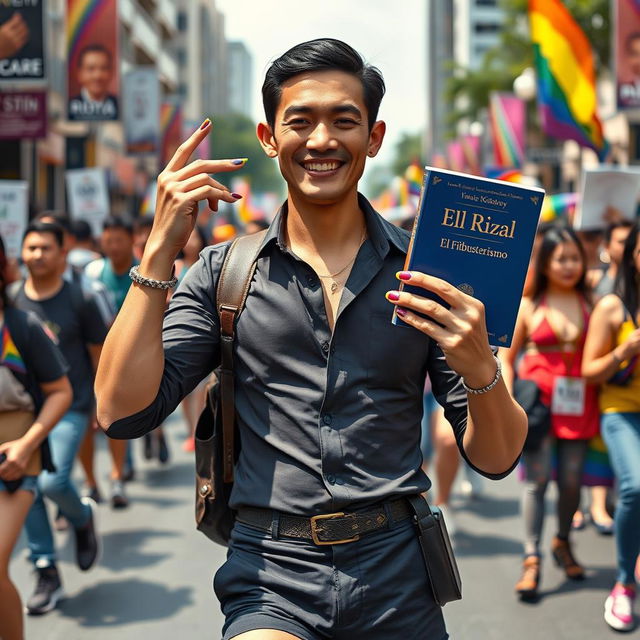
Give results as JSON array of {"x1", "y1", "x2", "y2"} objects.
[{"x1": 214, "y1": 519, "x2": 449, "y2": 640}]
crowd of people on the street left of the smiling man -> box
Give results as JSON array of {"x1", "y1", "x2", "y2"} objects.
[{"x1": 0, "y1": 212, "x2": 265, "y2": 640}]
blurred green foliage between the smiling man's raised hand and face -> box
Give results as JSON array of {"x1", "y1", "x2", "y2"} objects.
[{"x1": 210, "y1": 113, "x2": 284, "y2": 193}]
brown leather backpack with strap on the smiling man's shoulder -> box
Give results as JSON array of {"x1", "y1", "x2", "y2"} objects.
[{"x1": 195, "y1": 231, "x2": 266, "y2": 546}]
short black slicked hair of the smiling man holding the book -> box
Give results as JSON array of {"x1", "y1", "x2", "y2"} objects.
[{"x1": 262, "y1": 38, "x2": 385, "y2": 130}]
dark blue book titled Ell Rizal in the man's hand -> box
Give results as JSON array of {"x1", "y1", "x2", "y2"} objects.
[{"x1": 392, "y1": 167, "x2": 544, "y2": 347}]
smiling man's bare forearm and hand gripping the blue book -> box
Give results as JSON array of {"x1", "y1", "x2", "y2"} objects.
[{"x1": 391, "y1": 271, "x2": 527, "y2": 474}]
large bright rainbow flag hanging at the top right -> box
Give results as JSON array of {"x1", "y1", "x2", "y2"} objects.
[{"x1": 529, "y1": 0, "x2": 609, "y2": 160}]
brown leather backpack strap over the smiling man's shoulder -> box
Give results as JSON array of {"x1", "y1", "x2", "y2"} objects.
[{"x1": 216, "y1": 231, "x2": 266, "y2": 482}]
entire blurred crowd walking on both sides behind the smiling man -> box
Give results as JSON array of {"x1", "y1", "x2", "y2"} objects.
[{"x1": 0, "y1": 199, "x2": 640, "y2": 639}]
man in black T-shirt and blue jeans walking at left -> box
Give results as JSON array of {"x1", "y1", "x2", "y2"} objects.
[{"x1": 13, "y1": 222, "x2": 107, "y2": 614}]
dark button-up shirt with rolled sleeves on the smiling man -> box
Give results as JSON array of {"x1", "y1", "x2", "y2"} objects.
[{"x1": 108, "y1": 196, "x2": 504, "y2": 515}]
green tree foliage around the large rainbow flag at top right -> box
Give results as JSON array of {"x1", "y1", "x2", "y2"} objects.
[{"x1": 445, "y1": 0, "x2": 611, "y2": 137}]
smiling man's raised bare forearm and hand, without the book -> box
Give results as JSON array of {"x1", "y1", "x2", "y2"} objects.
[{"x1": 95, "y1": 120, "x2": 243, "y2": 430}]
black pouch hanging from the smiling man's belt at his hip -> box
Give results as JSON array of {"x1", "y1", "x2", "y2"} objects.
[{"x1": 409, "y1": 496, "x2": 462, "y2": 607}]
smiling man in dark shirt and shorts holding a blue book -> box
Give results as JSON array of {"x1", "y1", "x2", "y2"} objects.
[{"x1": 96, "y1": 39, "x2": 526, "y2": 640}]
